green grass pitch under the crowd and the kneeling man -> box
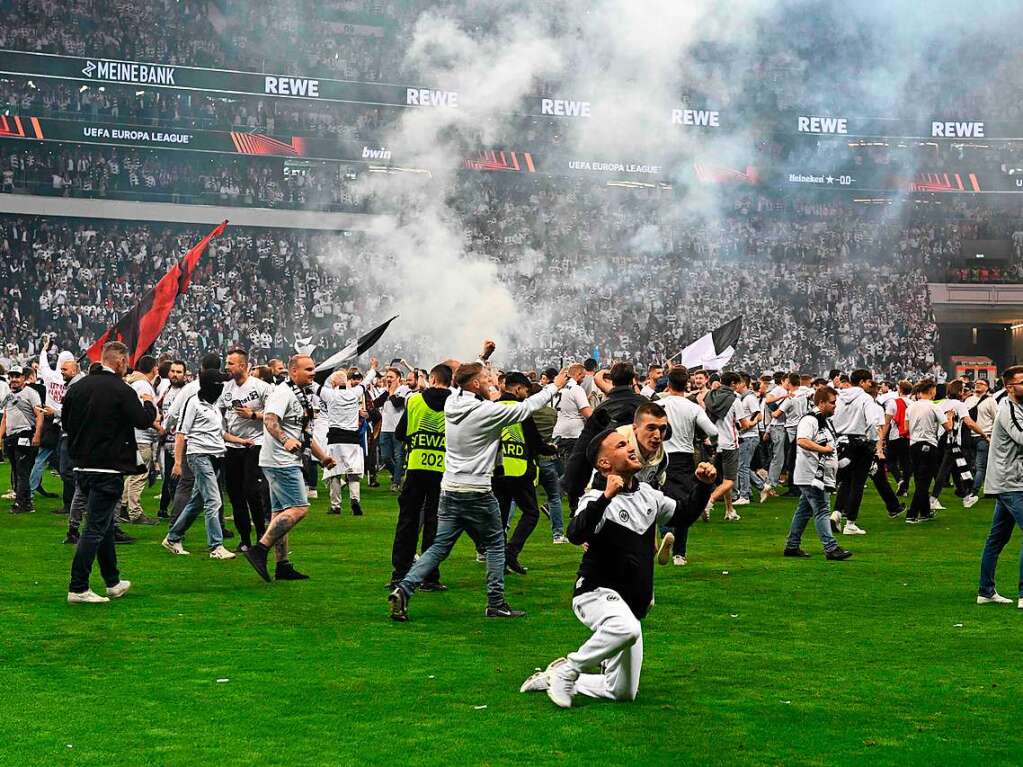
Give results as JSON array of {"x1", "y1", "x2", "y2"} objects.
[{"x1": 0, "y1": 467, "x2": 1023, "y2": 767}]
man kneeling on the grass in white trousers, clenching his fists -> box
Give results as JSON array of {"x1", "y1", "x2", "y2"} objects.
[{"x1": 521, "y1": 430, "x2": 717, "y2": 709}]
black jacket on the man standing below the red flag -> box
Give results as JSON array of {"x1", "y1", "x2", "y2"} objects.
[{"x1": 61, "y1": 370, "x2": 157, "y2": 473}]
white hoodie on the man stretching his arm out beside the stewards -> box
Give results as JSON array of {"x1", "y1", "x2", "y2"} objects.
[{"x1": 441, "y1": 384, "x2": 558, "y2": 493}]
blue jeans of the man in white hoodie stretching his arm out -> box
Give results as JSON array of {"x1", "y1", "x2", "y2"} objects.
[{"x1": 398, "y1": 490, "x2": 504, "y2": 607}]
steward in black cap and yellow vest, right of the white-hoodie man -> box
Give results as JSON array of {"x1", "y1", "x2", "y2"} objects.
[{"x1": 493, "y1": 372, "x2": 558, "y2": 575}]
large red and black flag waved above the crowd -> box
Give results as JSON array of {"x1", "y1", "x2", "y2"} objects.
[{"x1": 85, "y1": 221, "x2": 227, "y2": 365}]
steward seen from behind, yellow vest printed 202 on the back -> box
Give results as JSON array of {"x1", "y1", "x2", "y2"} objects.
[{"x1": 388, "y1": 365, "x2": 452, "y2": 591}]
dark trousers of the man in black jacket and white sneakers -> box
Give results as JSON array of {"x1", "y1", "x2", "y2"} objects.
[{"x1": 68, "y1": 471, "x2": 125, "y2": 594}]
